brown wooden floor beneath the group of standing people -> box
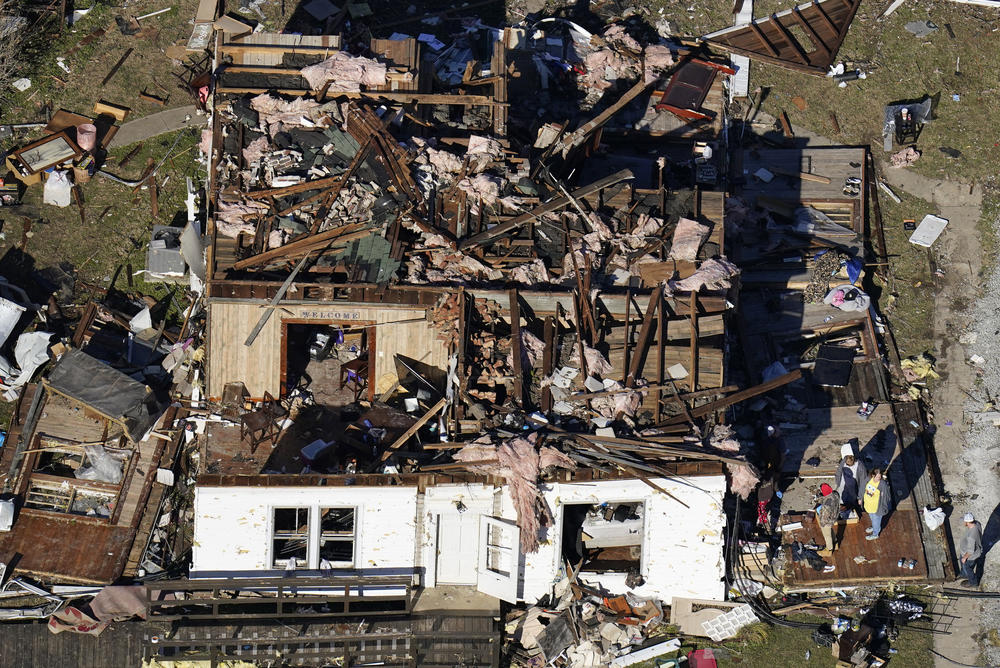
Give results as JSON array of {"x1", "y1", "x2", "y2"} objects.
[{"x1": 779, "y1": 506, "x2": 927, "y2": 586}]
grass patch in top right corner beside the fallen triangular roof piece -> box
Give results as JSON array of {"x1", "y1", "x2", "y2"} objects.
[{"x1": 751, "y1": 0, "x2": 1000, "y2": 181}]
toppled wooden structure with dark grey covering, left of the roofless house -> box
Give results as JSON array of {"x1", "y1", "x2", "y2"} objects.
[{"x1": 0, "y1": 349, "x2": 176, "y2": 584}]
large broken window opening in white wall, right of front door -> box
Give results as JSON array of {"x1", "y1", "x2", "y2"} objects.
[{"x1": 562, "y1": 501, "x2": 645, "y2": 573}]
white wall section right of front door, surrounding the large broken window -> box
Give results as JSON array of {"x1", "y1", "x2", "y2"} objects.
[{"x1": 503, "y1": 476, "x2": 726, "y2": 604}]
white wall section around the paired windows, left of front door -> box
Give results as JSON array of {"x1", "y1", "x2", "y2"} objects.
[{"x1": 191, "y1": 487, "x2": 417, "y2": 577}]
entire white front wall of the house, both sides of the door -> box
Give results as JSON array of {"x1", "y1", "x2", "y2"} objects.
[{"x1": 191, "y1": 476, "x2": 726, "y2": 604}]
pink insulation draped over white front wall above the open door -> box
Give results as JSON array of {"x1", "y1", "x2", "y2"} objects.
[{"x1": 455, "y1": 434, "x2": 576, "y2": 554}]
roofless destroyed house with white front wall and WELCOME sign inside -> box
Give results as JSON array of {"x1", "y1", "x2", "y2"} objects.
[{"x1": 157, "y1": 24, "x2": 749, "y2": 664}]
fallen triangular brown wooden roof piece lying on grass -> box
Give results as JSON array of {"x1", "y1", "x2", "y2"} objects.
[{"x1": 702, "y1": 0, "x2": 861, "y2": 75}]
